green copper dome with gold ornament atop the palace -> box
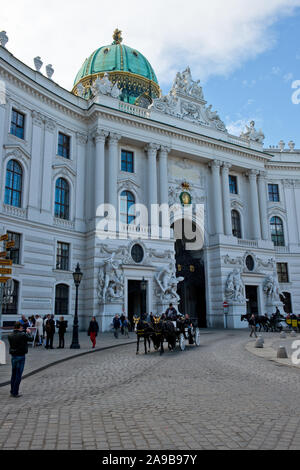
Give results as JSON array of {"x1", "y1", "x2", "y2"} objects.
[{"x1": 73, "y1": 30, "x2": 160, "y2": 104}]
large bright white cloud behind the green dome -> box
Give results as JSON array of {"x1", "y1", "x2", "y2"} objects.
[{"x1": 0, "y1": 0, "x2": 300, "y2": 88}]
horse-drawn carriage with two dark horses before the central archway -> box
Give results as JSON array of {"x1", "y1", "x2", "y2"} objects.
[{"x1": 133, "y1": 316, "x2": 200, "y2": 354}]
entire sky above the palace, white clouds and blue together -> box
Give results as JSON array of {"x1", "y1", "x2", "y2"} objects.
[{"x1": 0, "y1": 0, "x2": 300, "y2": 148}]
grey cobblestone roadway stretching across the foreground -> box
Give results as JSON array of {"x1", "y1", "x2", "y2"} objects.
[{"x1": 0, "y1": 331, "x2": 300, "y2": 450}]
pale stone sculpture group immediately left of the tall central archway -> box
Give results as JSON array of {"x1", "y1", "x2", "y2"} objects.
[{"x1": 155, "y1": 263, "x2": 184, "y2": 303}]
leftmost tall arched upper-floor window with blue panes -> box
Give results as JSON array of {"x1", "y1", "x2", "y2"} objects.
[{"x1": 4, "y1": 160, "x2": 23, "y2": 207}]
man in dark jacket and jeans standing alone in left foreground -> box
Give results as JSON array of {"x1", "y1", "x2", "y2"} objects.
[{"x1": 8, "y1": 322, "x2": 33, "y2": 398}]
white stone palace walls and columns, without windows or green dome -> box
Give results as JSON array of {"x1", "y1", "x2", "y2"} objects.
[{"x1": 0, "y1": 47, "x2": 300, "y2": 330}]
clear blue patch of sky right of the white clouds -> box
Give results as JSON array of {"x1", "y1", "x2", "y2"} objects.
[{"x1": 195, "y1": 11, "x2": 300, "y2": 148}]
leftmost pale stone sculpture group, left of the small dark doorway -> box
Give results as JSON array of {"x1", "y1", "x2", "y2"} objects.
[{"x1": 97, "y1": 253, "x2": 124, "y2": 302}]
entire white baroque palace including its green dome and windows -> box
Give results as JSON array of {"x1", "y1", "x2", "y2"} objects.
[{"x1": 0, "y1": 31, "x2": 300, "y2": 330}]
